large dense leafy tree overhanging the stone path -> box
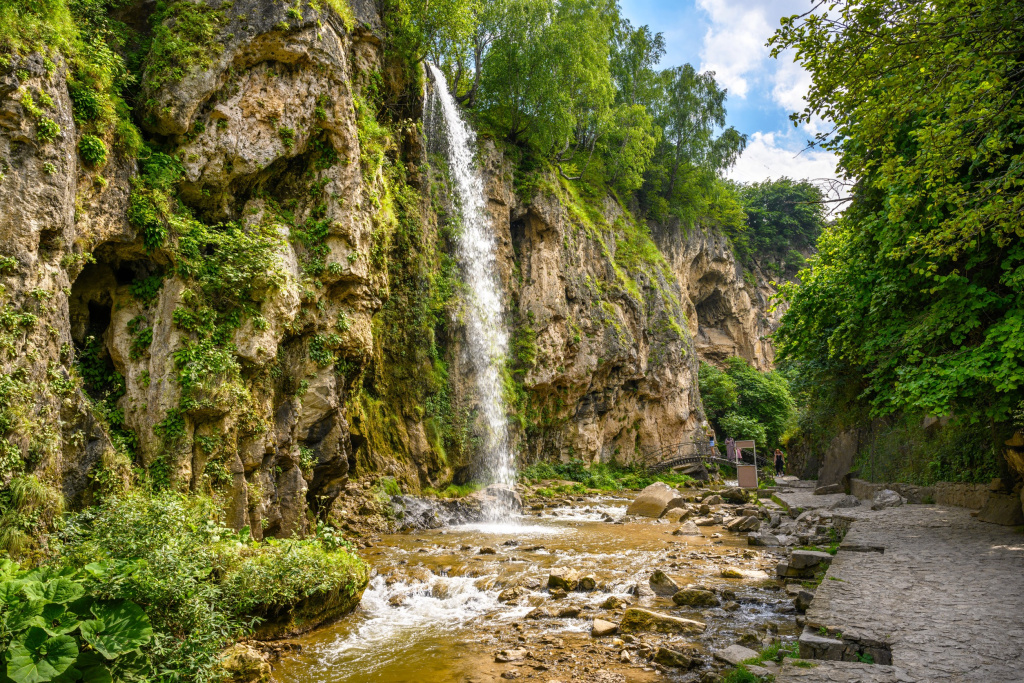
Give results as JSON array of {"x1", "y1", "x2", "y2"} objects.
[{"x1": 772, "y1": 0, "x2": 1024, "y2": 422}]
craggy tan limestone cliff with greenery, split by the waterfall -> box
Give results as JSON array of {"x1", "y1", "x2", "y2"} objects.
[{"x1": 0, "y1": 0, "x2": 774, "y2": 538}]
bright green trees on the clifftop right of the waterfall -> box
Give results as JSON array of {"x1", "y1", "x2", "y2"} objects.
[{"x1": 411, "y1": 0, "x2": 746, "y2": 229}]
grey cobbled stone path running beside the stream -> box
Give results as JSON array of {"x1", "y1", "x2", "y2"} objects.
[{"x1": 778, "y1": 492, "x2": 1024, "y2": 683}]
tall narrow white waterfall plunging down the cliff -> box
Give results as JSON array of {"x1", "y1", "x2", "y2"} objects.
[{"x1": 424, "y1": 63, "x2": 516, "y2": 521}]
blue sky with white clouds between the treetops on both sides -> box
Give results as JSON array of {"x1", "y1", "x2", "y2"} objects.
[{"x1": 620, "y1": 0, "x2": 836, "y2": 182}]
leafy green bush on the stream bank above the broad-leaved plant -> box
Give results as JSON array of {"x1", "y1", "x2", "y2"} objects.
[{"x1": 53, "y1": 492, "x2": 367, "y2": 681}]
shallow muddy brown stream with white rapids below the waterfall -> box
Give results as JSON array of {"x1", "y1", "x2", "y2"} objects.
[{"x1": 273, "y1": 498, "x2": 796, "y2": 683}]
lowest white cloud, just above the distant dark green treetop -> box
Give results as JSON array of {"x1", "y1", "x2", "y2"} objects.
[{"x1": 727, "y1": 132, "x2": 837, "y2": 182}]
